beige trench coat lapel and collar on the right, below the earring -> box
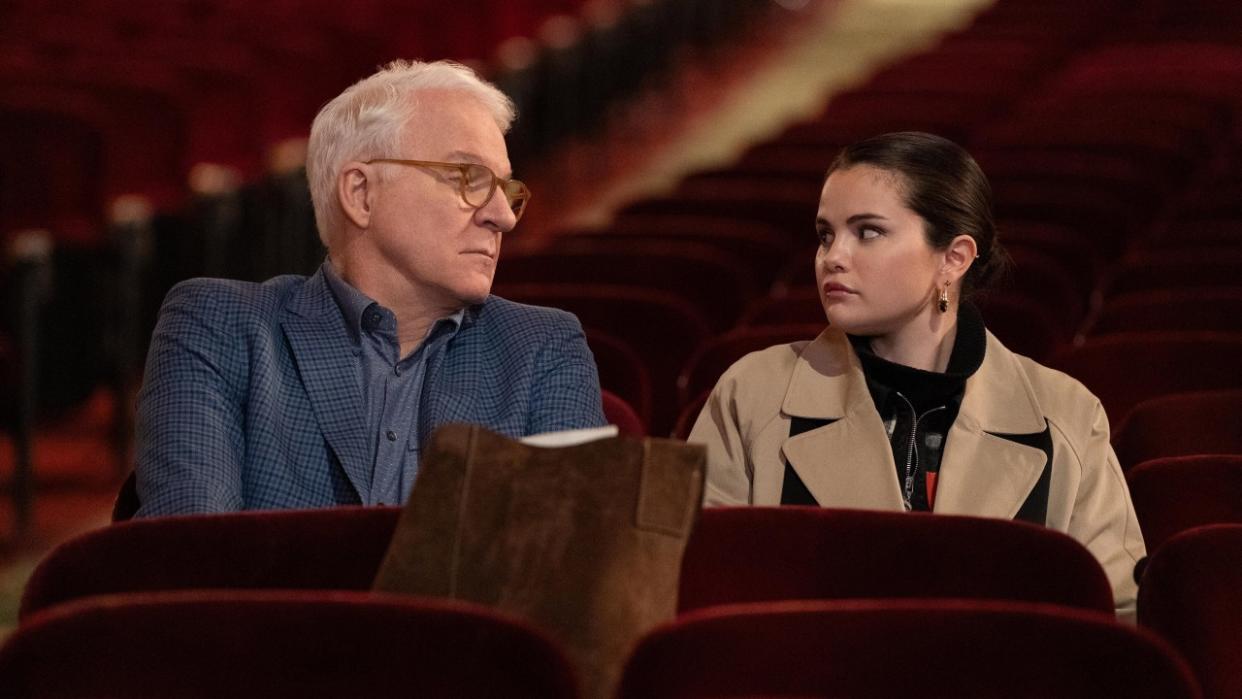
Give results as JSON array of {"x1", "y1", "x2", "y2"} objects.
[{"x1": 934, "y1": 333, "x2": 1052, "y2": 519}]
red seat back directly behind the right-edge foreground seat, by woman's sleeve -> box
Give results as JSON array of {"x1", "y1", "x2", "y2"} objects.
[{"x1": 1125, "y1": 454, "x2": 1242, "y2": 556}]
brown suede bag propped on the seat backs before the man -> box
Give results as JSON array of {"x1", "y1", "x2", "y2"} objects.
[{"x1": 375, "y1": 425, "x2": 705, "y2": 698}]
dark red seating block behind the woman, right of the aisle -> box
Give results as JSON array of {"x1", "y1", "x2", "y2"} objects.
[{"x1": 479, "y1": 0, "x2": 1242, "y2": 436}]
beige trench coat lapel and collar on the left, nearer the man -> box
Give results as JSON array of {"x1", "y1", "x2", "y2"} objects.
[{"x1": 781, "y1": 328, "x2": 902, "y2": 509}]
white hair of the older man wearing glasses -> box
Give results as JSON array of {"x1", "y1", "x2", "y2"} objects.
[{"x1": 307, "y1": 60, "x2": 515, "y2": 246}]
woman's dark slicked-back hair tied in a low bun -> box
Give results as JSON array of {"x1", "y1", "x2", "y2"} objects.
[{"x1": 825, "y1": 132, "x2": 1010, "y2": 295}]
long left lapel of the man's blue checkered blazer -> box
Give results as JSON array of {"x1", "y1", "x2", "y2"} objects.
[{"x1": 281, "y1": 269, "x2": 371, "y2": 503}]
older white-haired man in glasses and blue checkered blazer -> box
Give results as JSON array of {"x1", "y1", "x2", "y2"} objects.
[{"x1": 137, "y1": 61, "x2": 604, "y2": 516}]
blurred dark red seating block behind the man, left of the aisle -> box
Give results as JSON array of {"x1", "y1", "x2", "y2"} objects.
[{"x1": 0, "y1": 0, "x2": 771, "y2": 449}]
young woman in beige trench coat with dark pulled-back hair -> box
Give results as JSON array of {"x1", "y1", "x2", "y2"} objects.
[{"x1": 689, "y1": 133, "x2": 1145, "y2": 616}]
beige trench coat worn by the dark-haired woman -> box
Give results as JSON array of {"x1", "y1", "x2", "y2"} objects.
[{"x1": 688, "y1": 328, "x2": 1145, "y2": 620}]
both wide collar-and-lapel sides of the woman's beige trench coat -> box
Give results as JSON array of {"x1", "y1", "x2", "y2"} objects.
[{"x1": 781, "y1": 328, "x2": 1051, "y2": 519}]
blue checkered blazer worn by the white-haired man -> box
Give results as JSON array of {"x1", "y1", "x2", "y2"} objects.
[{"x1": 135, "y1": 265, "x2": 605, "y2": 516}]
